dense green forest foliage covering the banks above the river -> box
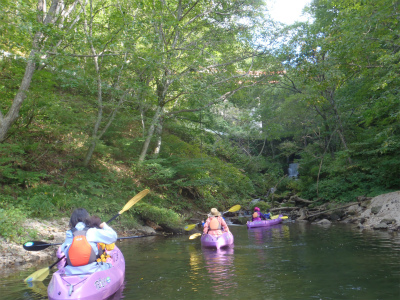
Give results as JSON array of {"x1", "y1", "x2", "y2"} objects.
[{"x1": 0, "y1": 0, "x2": 400, "y2": 239}]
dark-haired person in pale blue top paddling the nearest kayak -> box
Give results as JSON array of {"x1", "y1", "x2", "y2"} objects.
[{"x1": 60, "y1": 208, "x2": 117, "y2": 275}]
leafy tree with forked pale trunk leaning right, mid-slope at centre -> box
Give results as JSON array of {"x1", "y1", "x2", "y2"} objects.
[{"x1": 130, "y1": 0, "x2": 268, "y2": 162}]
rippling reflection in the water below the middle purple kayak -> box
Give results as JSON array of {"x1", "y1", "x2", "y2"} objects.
[{"x1": 202, "y1": 246, "x2": 237, "y2": 296}]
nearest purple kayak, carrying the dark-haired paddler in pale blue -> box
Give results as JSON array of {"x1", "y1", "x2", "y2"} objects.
[{"x1": 47, "y1": 246, "x2": 125, "y2": 300}]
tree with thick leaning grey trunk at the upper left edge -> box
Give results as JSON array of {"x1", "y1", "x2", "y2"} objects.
[{"x1": 0, "y1": 0, "x2": 83, "y2": 142}]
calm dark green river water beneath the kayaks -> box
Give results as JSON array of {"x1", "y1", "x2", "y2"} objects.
[{"x1": 0, "y1": 223, "x2": 400, "y2": 300}]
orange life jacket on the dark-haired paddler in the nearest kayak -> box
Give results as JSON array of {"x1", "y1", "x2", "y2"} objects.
[{"x1": 66, "y1": 227, "x2": 103, "y2": 267}]
